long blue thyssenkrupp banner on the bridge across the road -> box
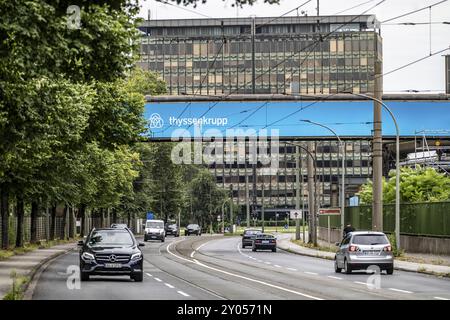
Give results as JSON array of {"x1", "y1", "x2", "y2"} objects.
[{"x1": 144, "y1": 101, "x2": 450, "y2": 138}]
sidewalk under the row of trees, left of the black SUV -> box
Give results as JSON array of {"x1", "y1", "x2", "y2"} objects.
[{"x1": 0, "y1": 243, "x2": 76, "y2": 299}]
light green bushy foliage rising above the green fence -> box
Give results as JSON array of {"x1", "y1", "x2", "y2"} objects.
[{"x1": 359, "y1": 167, "x2": 450, "y2": 204}]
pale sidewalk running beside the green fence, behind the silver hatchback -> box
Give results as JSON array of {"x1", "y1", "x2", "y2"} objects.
[{"x1": 277, "y1": 233, "x2": 450, "y2": 277}]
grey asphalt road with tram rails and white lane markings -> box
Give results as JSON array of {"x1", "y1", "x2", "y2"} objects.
[{"x1": 33, "y1": 236, "x2": 450, "y2": 300}]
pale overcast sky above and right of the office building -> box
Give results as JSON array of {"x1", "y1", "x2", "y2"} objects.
[{"x1": 140, "y1": 0, "x2": 450, "y2": 92}]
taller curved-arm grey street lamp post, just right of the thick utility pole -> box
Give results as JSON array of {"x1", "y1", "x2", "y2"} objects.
[{"x1": 349, "y1": 92, "x2": 400, "y2": 249}]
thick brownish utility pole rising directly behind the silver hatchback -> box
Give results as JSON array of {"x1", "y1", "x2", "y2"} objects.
[{"x1": 372, "y1": 61, "x2": 383, "y2": 231}]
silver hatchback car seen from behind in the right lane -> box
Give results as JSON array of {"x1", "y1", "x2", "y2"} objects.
[{"x1": 334, "y1": 231, "x2": 394, "y2": 274}]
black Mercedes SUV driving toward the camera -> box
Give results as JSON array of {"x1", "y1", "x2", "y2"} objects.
[{"x1": 78, "y1": 228, "x2": 145, "y2": 282}]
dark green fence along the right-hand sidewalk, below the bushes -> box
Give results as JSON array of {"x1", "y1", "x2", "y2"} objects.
[{"x1": 319, "y1": 202, "x2": 450, "y2": 237}]
